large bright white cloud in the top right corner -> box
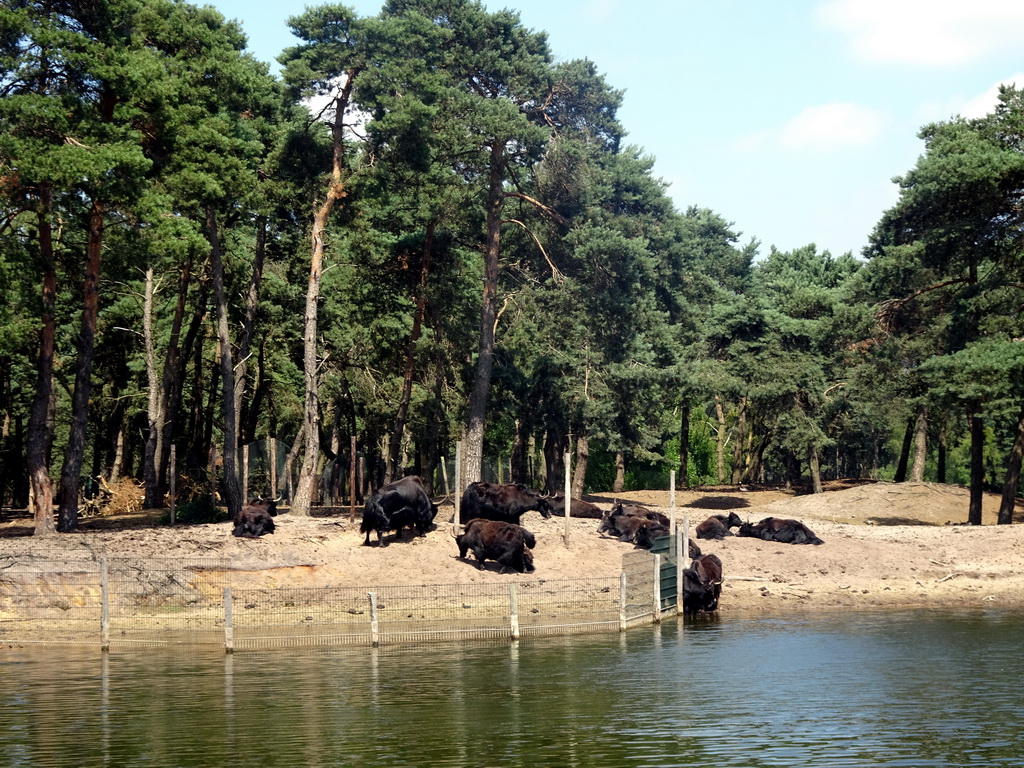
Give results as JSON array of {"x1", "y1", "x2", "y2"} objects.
[{"x1": 815, "y1": 0, "x2": 1024, "y2": 66}]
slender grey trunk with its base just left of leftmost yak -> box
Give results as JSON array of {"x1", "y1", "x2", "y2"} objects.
[{"x1": 206, "y1": 206, "x2": 242, "y2": 518}]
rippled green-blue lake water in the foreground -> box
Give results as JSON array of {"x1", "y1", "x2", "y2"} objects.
[{"x1": 0, "y1": 610, "x2": 1024, "y2": 768}]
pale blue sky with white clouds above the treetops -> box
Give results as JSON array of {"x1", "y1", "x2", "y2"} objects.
[{"x1": 207, "y1": 0, "x2": 1024, "y2": 256}]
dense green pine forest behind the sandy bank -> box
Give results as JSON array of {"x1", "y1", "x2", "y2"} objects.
[{"x1": 0, "y1": 0, "x2": 1024, "y2": 532}]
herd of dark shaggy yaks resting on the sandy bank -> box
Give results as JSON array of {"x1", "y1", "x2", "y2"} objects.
[{"x1": 232, "y1": 475, "x2": 822, "y2": 613}]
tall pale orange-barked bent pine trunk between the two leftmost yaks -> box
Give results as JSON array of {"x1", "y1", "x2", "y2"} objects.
[{"x1": 292, "y1": 75, "x2": 358, "y2": 516}]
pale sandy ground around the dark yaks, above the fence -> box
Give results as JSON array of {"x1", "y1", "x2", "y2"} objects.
[{"x1": 0, "y1": 483, "x2": 1024, "y2": 612}]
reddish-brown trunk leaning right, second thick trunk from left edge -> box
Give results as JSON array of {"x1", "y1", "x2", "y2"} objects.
[{"x1": 57, "y1": 201, "x2": 105, "y2": 532}]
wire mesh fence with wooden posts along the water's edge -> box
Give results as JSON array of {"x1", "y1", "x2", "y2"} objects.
[{"x1": 0, "y1": 536, "x2": 681, "y2": 651}]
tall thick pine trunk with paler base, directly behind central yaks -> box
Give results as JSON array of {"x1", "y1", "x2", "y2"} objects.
[{"x1": 462, "y1": 141, "x2": 504, "y2": 484}]
